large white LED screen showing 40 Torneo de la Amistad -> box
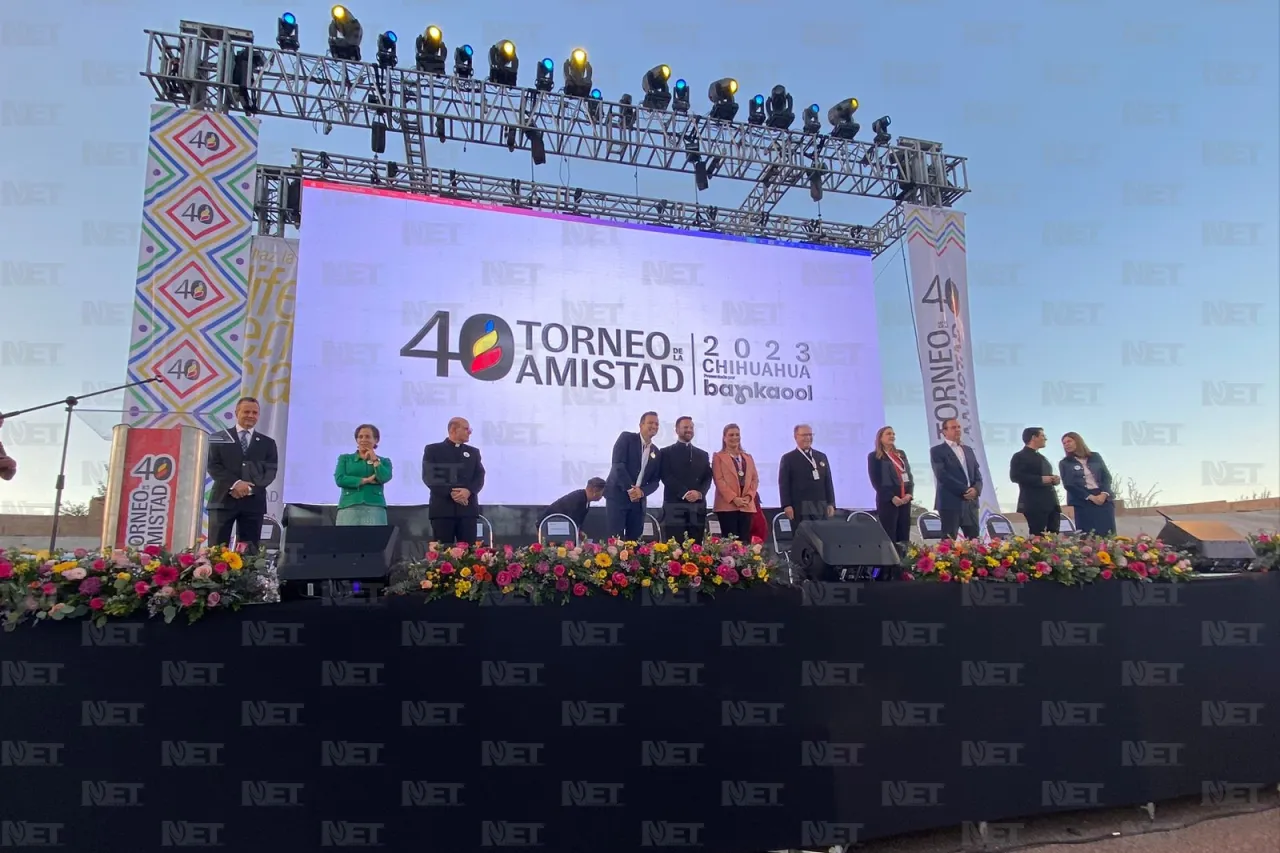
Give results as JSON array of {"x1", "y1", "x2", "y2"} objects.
[{"x1": 284, "y1": 182, "x2": 883, "y2": 507}]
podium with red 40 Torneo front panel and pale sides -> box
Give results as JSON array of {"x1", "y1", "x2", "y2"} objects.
[{"x1": 102, "y1": 424, "x2": 209, "y2": 551}]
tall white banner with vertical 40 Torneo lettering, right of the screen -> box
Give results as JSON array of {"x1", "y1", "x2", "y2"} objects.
[{"x1": 905, "y1": 205, "x2": 1000, "y2": 517}]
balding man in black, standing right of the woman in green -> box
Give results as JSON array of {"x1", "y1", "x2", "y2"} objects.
[{"x1": 422, "y1": 418, "x2": 484, "y2": 544}]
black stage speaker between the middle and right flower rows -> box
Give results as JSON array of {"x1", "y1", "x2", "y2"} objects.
[{"x1": 791, "y1": 515, "x2": 902, "y2": 580}]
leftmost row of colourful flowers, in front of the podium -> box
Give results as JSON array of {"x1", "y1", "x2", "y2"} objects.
[{"x1": 0, "y1": 546, "x2": 279, "y2": 630}]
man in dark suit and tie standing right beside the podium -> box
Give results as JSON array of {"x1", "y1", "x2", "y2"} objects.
[{"x1": 209, "y1": 397, "x2": 280, "y2": 551}]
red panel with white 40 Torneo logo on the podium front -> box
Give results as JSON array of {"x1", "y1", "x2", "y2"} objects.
[{"x1": 115, "y1": 428, "x2": 182, "y2": 551}]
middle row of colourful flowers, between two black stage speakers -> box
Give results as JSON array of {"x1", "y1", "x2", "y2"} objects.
[{"x1": 392, "y1": 538, "x2": 777, "y2": 602}]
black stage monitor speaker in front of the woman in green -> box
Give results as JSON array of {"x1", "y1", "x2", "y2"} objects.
[{"x1": 279, "y1": 525, "x2": 399, "y2": 581}]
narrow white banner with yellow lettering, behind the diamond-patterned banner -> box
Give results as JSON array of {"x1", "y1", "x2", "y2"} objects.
[{"x1": 239, "y1": 237, "x2": 298, "y2": 520}]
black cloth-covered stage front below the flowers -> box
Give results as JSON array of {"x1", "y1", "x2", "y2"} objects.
[{"x1": 0, "y1": 574, "x2": 1280, "y2": 853}]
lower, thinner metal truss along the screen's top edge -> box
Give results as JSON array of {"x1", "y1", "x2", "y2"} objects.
[{"x1": 253, "y1": 150, "x2": 902, "y2": 255}]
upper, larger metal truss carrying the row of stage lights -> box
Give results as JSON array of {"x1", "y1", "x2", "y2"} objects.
[{"x1": 142, "y1": 22, "x2": 969, "y2": 229}]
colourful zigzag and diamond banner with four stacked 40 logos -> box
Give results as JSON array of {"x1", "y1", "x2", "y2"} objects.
[{"x1": 123, "y1": 105, "x2": 259, "y2": 430}]
